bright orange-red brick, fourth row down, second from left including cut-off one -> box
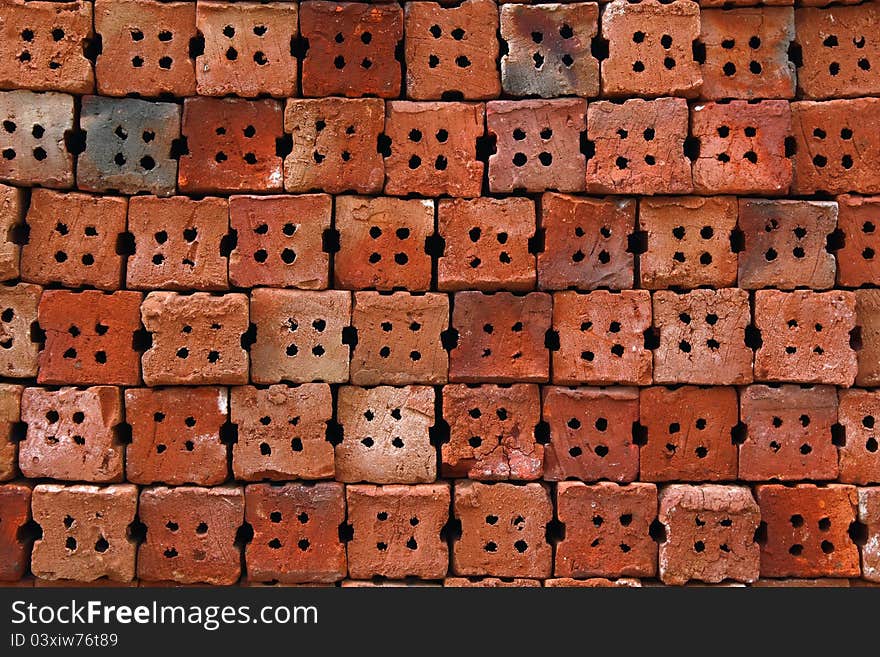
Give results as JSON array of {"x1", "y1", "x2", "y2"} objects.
[{"x1": 37, "y1": 290, "x2": 141, "y2": 386}]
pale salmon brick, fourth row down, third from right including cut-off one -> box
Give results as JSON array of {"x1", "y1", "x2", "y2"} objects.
[{"x1": 654, "y1": 288, "x2": 752, "y2": 385}]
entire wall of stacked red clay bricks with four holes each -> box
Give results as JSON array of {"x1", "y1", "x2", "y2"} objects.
[{"x1": 0, "y1": 0, "x2": 880, "y2": 588}]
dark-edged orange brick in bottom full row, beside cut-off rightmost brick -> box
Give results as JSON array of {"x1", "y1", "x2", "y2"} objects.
[{"x1": 755, "y1": 484, "x2": 859, "y2": 577}]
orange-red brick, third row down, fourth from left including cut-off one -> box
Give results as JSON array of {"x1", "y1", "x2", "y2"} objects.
[{"x1": 229, "y1": 194, "x2": 333, "y2": 290}]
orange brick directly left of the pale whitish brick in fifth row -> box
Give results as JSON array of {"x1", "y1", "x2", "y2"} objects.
[{"x1": 230, "y1": 383, "x2": 334, "y2": 481}]
